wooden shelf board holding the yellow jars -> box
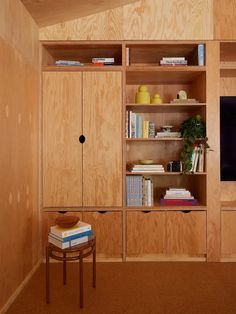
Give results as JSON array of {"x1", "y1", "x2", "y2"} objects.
[{"x1": 126, "y1": 102, "x2": 206, "y2": 113}]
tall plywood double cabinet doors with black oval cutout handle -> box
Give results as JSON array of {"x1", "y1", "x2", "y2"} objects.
[{"x1": 42, "y1": 71, "x2": 122, "y2": 208}]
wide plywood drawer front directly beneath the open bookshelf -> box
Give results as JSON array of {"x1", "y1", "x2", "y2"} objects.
[{"x1": 126, "y1": 211, "x2": 206, "y2": 260}]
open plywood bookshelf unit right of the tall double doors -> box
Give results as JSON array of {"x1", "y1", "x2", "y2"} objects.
[{"x1": 124, "y1": 42, "x2": 207, "y2": 210}]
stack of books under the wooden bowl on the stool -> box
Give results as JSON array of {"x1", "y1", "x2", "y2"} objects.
[{"x1": 48, "y1": 221, "x2": 93, "y2": 249}]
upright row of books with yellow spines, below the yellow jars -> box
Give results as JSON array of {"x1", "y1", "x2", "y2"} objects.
[{"x1": 125, "y1": 110, "x2": 155, "y2": 138}]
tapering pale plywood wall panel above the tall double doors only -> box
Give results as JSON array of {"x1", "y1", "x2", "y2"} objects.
[{"x1": 40, "y1": 8, "x2": 123, "y2": 40}]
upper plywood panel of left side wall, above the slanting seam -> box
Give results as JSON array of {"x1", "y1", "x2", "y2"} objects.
[{"x1": 0, "y1": 0, "x2": 39, "y2": 68}]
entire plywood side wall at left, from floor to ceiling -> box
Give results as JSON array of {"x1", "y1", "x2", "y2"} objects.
[{"x1": 0, "y1": 4, "x2": 41, "y2": 309}]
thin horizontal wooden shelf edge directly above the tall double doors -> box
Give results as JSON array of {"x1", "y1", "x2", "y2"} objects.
[{"x1": 42, "y1": 64, "x2": 123, "y2": 72}]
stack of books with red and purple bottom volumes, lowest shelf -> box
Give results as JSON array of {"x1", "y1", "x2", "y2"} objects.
[{"x1": 160, "y1": 188, "x2": 198, "y2": 206}]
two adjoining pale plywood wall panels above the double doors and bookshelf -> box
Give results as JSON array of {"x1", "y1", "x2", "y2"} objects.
[{"x1": 40, "y1": 0, "x2": 213, "y2": 40}]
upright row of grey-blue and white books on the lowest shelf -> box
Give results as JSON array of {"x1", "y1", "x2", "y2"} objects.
[{"x1": 126, "y1": 175, "x2": 154, "y2": 206}]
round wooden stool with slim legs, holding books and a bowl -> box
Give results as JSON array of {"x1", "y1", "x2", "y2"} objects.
[{"x1": 46, "y1": 237, "x2": 96, "y2": 308}]
